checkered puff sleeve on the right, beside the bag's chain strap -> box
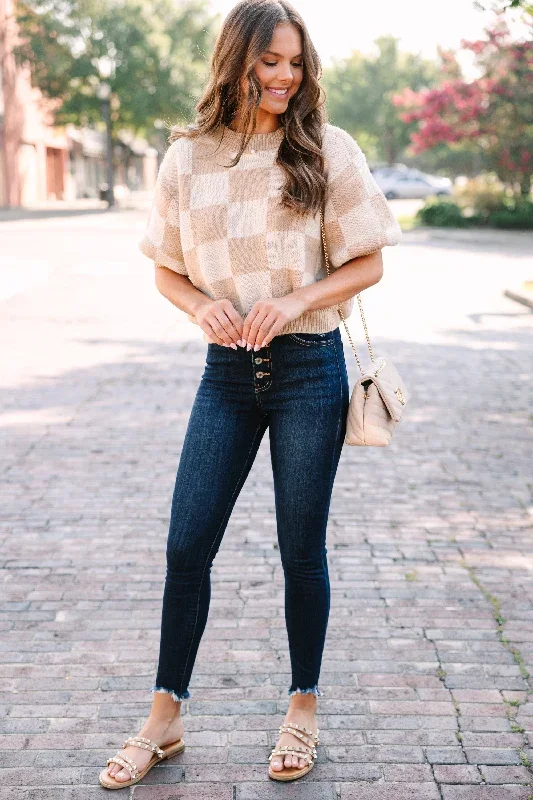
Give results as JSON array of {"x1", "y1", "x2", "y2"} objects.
[{"x1": 323, "y1": 124, "x2": 402, "y2": 268}]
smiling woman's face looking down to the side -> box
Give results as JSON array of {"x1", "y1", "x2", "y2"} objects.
[{"x1": 247, "y1": 22, "x2": 303, "y2": 115}]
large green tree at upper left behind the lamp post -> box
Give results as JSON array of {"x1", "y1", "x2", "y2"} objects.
[{"x1": 16, "y1": 0, "x2": 216, "y2": 135}]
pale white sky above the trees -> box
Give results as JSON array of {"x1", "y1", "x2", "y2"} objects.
[{"x1": 206, "y1": 0, "x2": 521, "y2": 77}]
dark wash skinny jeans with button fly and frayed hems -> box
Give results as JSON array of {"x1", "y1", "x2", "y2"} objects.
[{"x1": 152, "y1": 328, "x2": 349, "y2": 700}]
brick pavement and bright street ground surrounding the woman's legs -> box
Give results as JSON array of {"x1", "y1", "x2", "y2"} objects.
[{"x1": 0, "y1": 213, "x2": 533, "y2": 800}]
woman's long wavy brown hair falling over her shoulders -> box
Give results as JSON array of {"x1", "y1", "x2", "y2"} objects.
[{"x1": 169, "y1": 0, "x2": 327, "y2": 213}]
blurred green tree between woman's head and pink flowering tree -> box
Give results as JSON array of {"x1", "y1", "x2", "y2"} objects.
[{"x1": 324, "y1": 36, "x2": 438, "y2": 164}]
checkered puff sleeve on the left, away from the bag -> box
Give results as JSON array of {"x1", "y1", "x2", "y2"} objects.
[{"x1": 139, "y1": 142, "x2": 188, "y2": 275}]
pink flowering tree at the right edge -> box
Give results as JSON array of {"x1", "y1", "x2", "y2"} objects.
[{"x1": 393, "y1": 19, "x2": 533, "y2": 196}]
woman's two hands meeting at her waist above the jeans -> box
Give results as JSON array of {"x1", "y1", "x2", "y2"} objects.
[{"x1": 195, "y1": 293, "x2": 306, "y2": 350}]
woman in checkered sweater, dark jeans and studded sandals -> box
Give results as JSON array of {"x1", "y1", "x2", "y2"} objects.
[{"x1": 100, "y1": 0, "x2": 401, "y2": 788}]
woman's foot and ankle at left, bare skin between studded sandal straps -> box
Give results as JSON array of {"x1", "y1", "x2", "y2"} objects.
[{"x1": 107, "y1": 693, "x2": 184, "y2": 781}]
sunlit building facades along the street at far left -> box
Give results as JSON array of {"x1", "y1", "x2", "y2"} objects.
[{"x1": 0, "y1": 0, "x2": 158, "y2": 208}]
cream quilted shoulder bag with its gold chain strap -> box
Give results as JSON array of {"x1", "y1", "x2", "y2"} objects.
[{"x1": 320, "y1": 211, "x2": 408, "y2": 447}]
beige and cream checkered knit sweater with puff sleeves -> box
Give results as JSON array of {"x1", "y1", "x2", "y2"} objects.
[{"x1": 139, "y1": 123, "x2": 401, "y2": 341}]
